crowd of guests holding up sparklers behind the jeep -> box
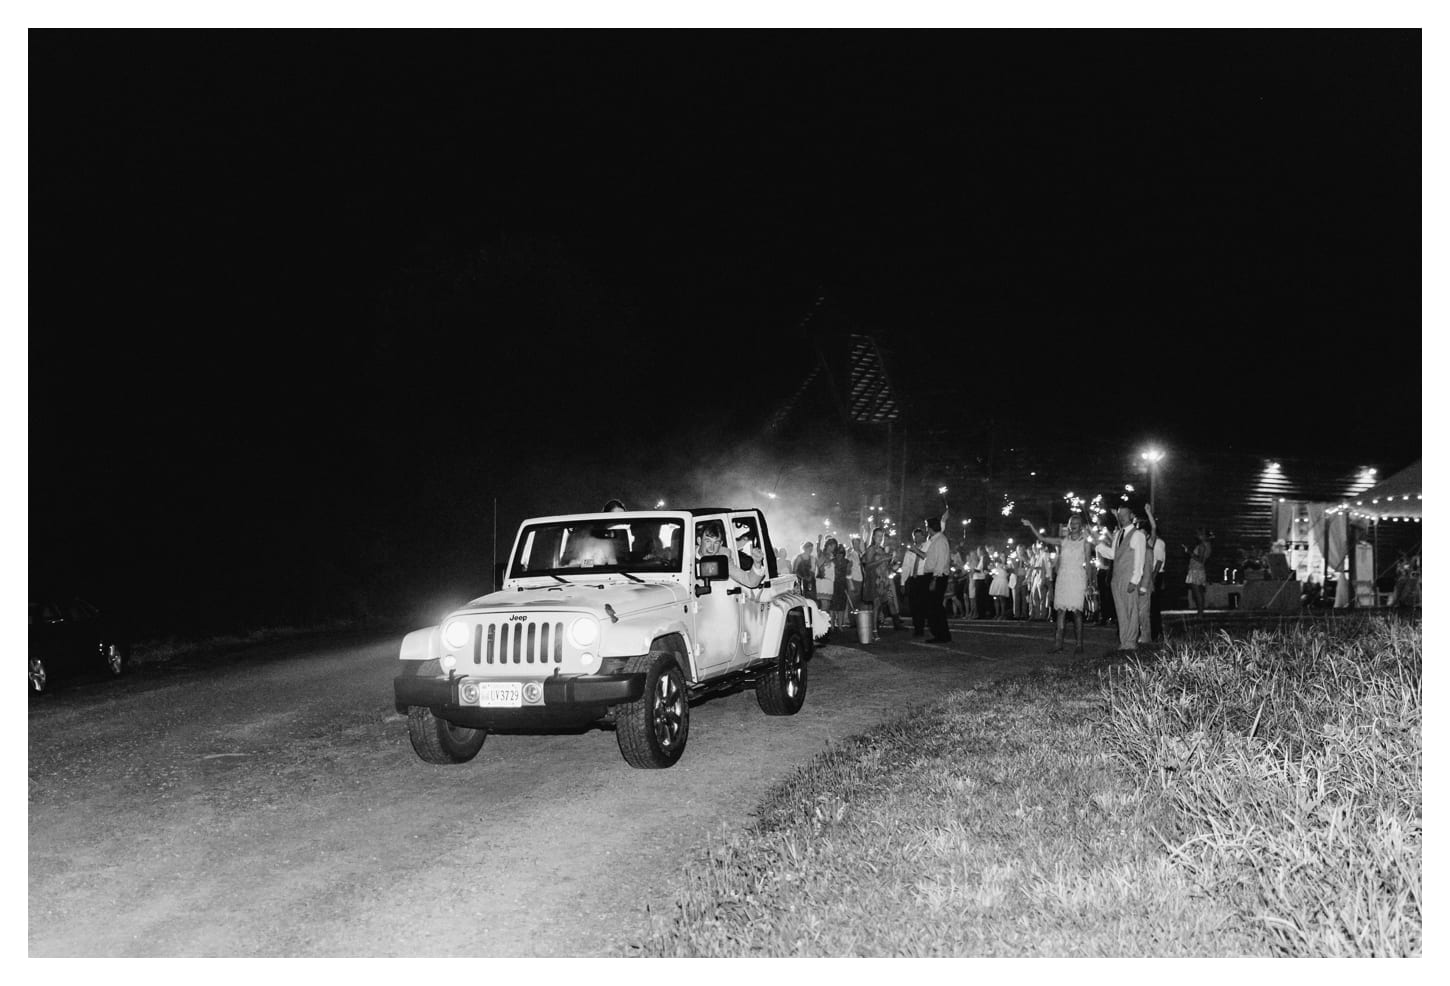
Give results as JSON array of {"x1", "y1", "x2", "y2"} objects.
[{"x1": 779, "y1": 503, "x2": 1189, "y2": 651}]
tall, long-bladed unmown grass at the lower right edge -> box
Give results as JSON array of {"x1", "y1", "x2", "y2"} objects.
[{"x1": 1103, "y1": 619, "x2": 1422, "y2": 956}]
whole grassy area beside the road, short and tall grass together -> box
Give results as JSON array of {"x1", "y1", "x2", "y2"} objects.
[{"x1": 621, "y1": 618, "x2": 1422, "y2": 956}]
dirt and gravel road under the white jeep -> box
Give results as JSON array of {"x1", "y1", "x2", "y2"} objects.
[{"x1": 29, "y1": 624, "x2": 1112, "y2": 956}]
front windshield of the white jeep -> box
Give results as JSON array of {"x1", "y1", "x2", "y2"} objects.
[{"x1": 509, "y1": 518, "x2": 684, "y2": 579}]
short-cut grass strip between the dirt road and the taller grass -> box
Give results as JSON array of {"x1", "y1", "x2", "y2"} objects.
[{"x1": 621, "y1": 671, "x2": 1264, "y2": 957}]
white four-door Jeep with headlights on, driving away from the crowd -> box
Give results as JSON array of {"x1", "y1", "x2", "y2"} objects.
[{"x1": 393, "y1": 508, "x2": 829, "y2": 767}]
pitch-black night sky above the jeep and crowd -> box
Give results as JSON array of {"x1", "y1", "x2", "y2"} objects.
[{"x1": 29, "y1": 30, "x2": 1421, "y2": 632}]
